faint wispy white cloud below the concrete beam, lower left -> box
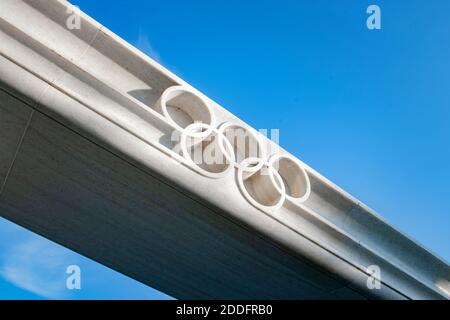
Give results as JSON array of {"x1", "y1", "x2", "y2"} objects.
[{"x1": 0, "y1": 237, "x2": 73, "y2": 299}]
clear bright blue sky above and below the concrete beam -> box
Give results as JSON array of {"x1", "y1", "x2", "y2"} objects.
[{"x1": 0, "y1": 0, "x2": 450, "y2": 299}]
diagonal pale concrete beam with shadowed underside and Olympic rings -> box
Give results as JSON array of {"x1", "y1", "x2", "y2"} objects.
[{"x1": 0, "y1": 0, "x2": 450, "y2": 299}]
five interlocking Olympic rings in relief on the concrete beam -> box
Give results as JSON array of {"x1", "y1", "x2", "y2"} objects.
[{"x1": 154, "y1": 86, "x2": 311, "y2": 212}]
